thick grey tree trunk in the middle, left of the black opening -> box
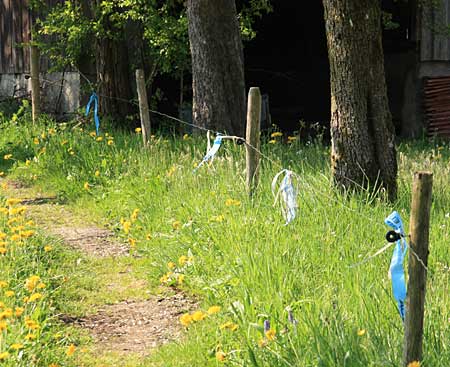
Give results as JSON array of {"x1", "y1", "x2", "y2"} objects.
[{"x1": 187, "y1": 0, "x2": 245, "y2": 136}]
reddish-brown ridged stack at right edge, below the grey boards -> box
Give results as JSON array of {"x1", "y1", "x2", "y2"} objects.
[{"x1": 424, "y1": 76, "x2": 450, "y2": 137}]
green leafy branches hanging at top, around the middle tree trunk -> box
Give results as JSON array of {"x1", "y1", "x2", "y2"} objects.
[{"x1": 35, "y1": 0, "x2": 271, "y2": 75}]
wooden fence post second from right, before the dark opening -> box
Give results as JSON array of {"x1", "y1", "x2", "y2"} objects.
[{"x1": 245, "y1": 87, "x2": 261, "y2": 196}]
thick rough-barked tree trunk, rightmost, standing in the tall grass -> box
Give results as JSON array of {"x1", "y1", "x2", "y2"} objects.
[{"x1": 323, "y1": 0, "x2": 397, "y2": 200}]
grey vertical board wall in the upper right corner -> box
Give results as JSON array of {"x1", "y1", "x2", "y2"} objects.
[{"x1": 420, "y1": 0, "x2": 450, "y2": 61}]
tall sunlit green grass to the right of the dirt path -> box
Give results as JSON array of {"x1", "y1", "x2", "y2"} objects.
[{"x1": 0, "y1": 105, "x2": 450, "y2": 367}]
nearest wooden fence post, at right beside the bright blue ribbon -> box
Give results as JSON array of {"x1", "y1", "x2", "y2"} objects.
[{"x1": 403, "y1": 172, "x2": 433, "y2": 367}]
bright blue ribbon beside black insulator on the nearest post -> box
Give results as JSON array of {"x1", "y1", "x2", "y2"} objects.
[{"x1": 384, "y1": 211, "x2": 408, "y2": 321}]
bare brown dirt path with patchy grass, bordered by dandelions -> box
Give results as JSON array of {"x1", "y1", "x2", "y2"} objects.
[{"x1": 2, "y1": 182, "x2": 195, "y2": 360}]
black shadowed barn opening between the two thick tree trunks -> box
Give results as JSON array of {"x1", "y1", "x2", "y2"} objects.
[{"x1": 244, "y1": 1, "x2": 330, "y2": 131}]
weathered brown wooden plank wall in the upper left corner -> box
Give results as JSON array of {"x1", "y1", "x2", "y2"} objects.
[{"x1": 0, "y1": 0, "x2": 63, "y2": 74}]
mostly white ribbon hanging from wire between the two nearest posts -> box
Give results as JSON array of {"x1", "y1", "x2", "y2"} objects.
[{"x1": 272, "y1": 169, "x2": 297, "y2": 225}]
